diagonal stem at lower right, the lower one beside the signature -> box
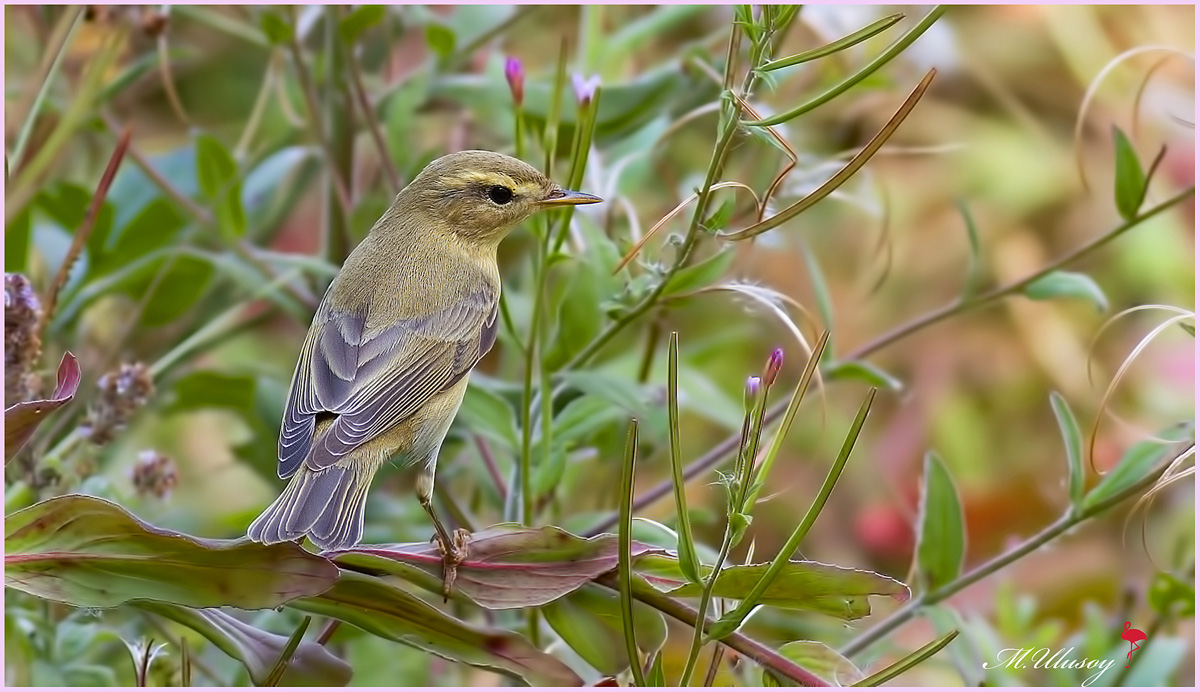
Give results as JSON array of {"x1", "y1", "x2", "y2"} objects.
[{"x1": 841, "y1": 443, "x2": 1193, "y2": 657}]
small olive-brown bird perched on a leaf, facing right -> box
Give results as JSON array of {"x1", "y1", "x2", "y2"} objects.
[{"x1": 247, "y1": 151, "x2": 601, "y2": 587}]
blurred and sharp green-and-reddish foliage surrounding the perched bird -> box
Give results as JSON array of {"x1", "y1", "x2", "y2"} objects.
[{"x1": 5, "y1": 5, "x2": 1195, "y2": 686}]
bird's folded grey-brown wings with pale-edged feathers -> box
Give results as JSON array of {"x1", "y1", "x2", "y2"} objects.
[{"x1": 278, "y1": 285, "x2": 499, "y2": 479}]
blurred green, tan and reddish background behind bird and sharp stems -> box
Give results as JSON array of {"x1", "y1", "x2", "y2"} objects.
[{"x1": 5, "y1": 6, "x2": 1195, "y2": 685}]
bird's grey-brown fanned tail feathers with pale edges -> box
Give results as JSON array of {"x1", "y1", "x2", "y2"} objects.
[{"x1": 246, "y1": 463, "x2": 377, "y2": 550}]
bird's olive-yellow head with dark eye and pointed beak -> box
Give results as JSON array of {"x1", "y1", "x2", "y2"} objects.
[{"x1": 397, "y1": 151, "x2": 601, "y2": 243}]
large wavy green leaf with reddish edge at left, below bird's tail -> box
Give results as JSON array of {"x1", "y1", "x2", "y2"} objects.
[{"x1": 5, "y1": 495, "x2": 337, "y2": 609}]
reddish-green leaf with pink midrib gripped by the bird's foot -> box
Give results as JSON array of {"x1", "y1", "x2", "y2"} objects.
[{"x1": 326, "y1": 524, "x2": 665, "y2": 609}]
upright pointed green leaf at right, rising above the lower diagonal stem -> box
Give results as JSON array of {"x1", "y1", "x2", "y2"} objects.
[{"x1": 917, "y1": 452, "x2": 967, "y2": 592}]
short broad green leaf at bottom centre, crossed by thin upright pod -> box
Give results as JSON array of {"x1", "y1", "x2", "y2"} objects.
[{"x1": 541, "y1": 584, "x2": 667, "y2": 675}]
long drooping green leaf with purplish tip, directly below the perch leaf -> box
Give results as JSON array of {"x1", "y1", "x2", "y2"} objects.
[{"x1": 290, "y1": 566, "x2": 583, "y2": 687}]
